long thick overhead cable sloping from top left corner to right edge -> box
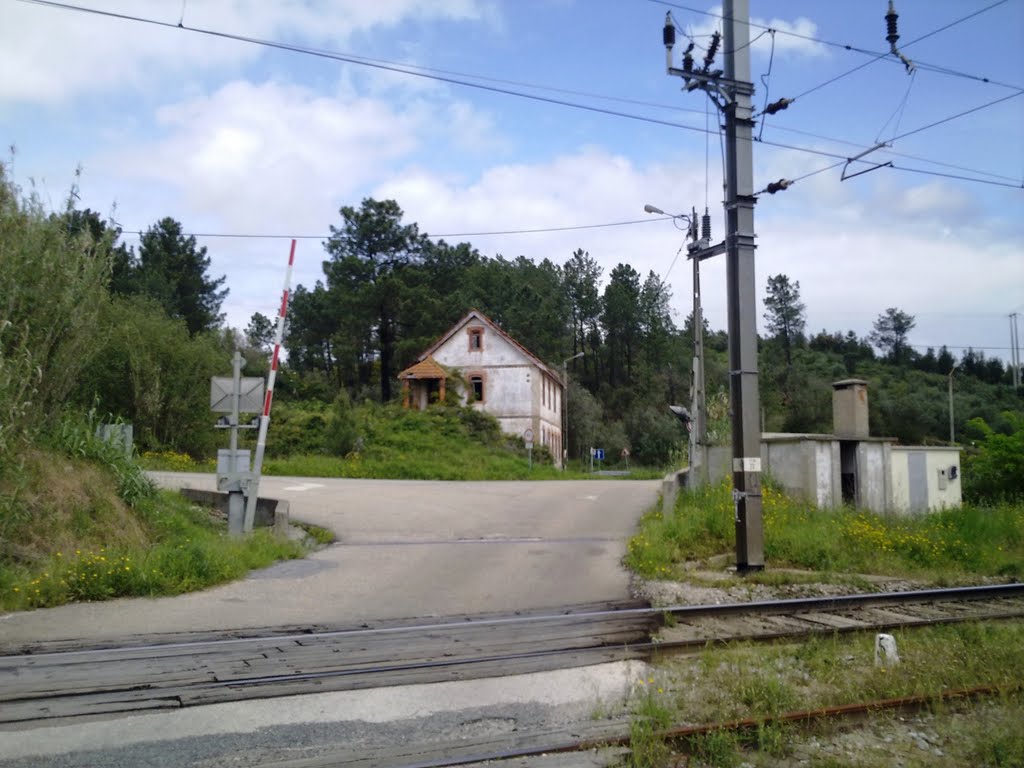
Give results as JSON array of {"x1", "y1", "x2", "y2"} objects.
[{"x1": 17, "y1": 0, "x2": 1021, "y2": 188}]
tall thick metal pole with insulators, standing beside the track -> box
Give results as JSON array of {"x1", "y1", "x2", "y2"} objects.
[{"x1": 663, "y1": 0, "x2": 764, "y2": 573}]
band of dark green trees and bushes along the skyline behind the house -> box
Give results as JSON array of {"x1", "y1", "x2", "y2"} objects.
[{"x1": 0, "y1": 167, "x2": 1021, "y2": 464}]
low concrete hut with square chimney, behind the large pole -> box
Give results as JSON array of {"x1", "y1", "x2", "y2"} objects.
[{"x1": 706, "y1": 379, "x2": 962, "y2": 514}]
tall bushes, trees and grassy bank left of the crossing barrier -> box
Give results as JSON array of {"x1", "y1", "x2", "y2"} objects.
[{"x1": 0, "y1": 164, "x2": 302, "y2": 610}]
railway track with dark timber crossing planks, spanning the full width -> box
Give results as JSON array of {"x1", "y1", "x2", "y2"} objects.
[{"x1": 0, "y1": 584, "x2": 1024, "y2": 727}]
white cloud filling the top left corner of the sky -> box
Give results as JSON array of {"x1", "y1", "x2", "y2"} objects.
[{"x1": 0, "y1": 0, "x2": 497, "y2": 103}]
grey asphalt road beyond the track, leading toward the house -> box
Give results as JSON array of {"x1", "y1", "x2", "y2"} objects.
[{"x1": 0, "y1": 472, "x2": 658, "y2": 652}]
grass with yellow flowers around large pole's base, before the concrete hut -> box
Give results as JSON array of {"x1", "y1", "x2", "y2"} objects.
[{"x1": 626, "y1": 483, "x2": 1024, "y2": 583}]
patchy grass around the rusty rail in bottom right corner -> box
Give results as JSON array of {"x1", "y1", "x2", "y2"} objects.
[{"x1": 633, "y1": 622, "x2": 1024, "y2": 768}]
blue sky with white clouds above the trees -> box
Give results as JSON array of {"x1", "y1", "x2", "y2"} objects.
[{"x1": 0, "y1": 0, "x2": 1024, "y2": 361}]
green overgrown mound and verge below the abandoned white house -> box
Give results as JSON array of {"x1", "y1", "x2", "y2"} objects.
[{"x1": 143, "y1": 406, "x2": 664, "y2": 480}]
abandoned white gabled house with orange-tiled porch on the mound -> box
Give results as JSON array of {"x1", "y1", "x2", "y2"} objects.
[{"x1": 398, "y1": 309, "x2": 565, "y2": 466}]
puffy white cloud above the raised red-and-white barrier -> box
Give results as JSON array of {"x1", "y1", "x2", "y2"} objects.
[{"x1": 116, "y1": 81, "x2": 424, "y2": 231}]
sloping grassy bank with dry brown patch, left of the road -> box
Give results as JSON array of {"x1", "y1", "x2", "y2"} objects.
[{"x1": 0, "y1": 415, "x2": 303, "y2": 610}]
